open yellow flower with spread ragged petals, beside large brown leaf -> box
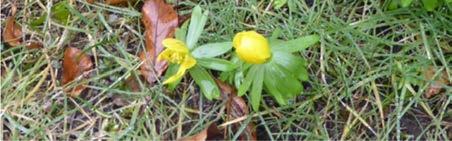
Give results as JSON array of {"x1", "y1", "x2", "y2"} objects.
[{"x1": 157, "y1": 38, "x2": 196, "y2": 84}]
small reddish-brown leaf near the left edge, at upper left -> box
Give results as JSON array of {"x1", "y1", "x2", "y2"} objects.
[{"x1": 3, "y1": 14, "x2": 22, "y2": 47}]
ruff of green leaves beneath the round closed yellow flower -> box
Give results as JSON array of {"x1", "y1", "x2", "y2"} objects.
[{"x1": 234, "y1": 35, "x2": 320, "y2": 111}]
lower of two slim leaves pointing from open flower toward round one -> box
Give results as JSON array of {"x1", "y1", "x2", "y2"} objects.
[{"x1": 196, "y1": 58, "x2": 237, "y2": 71}]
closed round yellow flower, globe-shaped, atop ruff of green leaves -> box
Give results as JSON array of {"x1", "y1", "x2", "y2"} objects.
[{"x1": 232, "y1": 31, "x2": 271, "y2": 64}]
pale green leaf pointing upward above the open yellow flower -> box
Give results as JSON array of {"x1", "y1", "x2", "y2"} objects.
[{"x1": 186, "y1": 5, "x2": 209, "y2": 49}]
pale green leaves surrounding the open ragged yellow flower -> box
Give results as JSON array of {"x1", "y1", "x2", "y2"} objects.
[{"x1": 168, "y1": 6, "x2": 236, "y2": 100}]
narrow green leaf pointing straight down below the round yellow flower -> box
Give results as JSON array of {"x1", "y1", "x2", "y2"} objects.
[{"x1": 250, "y1": 65, "x2": 265, "y2": 111}]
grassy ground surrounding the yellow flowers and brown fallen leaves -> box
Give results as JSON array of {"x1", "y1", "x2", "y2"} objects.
[{"x1": 0, "y1": 0, "x2": 452, "y2": 140}]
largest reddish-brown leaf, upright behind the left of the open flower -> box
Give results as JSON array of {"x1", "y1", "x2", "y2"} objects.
[{"x1": 140, "y1": 0, "x2": 178, "y2": 84}]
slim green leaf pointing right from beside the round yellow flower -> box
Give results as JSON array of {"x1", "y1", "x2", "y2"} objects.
[{"x1": 272, "y1": 35, "x2": 320, "y2": 52}]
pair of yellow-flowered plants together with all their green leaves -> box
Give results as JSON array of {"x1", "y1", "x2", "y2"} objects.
[{"x1": 158, "y1": 6, "x2": 319, "y2": 111}]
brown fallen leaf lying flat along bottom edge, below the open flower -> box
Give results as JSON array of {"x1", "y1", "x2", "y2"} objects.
[{"x1": 177, "y1": 123, "x2": 224, "y2": 141}]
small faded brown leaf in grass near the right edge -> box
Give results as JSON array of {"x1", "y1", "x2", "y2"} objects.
[{"x1": 424, "y1": 66, "x2": 451, "y2": 98}]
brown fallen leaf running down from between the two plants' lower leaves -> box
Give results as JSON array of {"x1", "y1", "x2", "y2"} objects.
[{"x1": 215, "y1": 79, "x2": 257, "y2": 140}]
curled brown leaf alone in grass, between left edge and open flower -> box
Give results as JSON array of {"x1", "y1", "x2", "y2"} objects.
[{"x1": 61, "y1": 47, "x2": 93, "y2": 97}]
